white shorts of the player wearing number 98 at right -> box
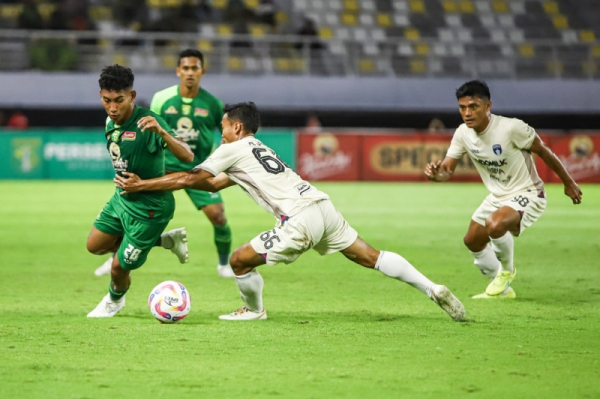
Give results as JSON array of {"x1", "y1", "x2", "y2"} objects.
[{"x1": 471, "y1": 191, "x2": 547, "y2": 233}]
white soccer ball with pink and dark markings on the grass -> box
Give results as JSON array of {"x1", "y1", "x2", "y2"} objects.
[{"x1": 148, "y1": 281, "x2": 192, "y2": 323}]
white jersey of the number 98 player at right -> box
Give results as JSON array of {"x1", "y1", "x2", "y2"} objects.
[{"x1": 446, "y1": 114, "x2": 544, "y2": 198}]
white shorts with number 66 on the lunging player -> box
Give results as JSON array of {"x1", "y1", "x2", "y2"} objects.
[{"x1": 250, "y1": 200, "x2": 358, "y2": 266}]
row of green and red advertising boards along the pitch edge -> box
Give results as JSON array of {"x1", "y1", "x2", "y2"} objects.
[{"x1": 0, "y1": 129, "x2": 600, "y2": 183}]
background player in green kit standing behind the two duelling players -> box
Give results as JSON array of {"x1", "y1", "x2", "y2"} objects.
[{"x1": 150, "y1": 49, "x2": 234, "y2": 277}]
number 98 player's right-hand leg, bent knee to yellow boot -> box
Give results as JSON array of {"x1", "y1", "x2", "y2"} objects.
[{"x1": 485, "y1": 206, "x2": 522, "y2": 296}]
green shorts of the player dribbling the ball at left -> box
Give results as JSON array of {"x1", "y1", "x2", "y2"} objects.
[{"x1": 94, "y1": 199, "x2": 169, "y2": 270}]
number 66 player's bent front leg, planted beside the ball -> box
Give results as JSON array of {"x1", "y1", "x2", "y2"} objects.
[{"x1": 219, "y1": 243, "x2": 267, "y2": 320}]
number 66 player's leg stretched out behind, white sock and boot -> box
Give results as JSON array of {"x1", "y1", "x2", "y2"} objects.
[{"x1": 342, "y1": 237, "x2": 466, "y2": 321}]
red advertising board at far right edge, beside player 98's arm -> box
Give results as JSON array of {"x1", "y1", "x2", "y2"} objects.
[{"x1": 550, "y1": 132, "x2": 600, "y2": 183}]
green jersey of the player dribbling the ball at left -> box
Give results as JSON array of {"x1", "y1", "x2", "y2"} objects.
[{"x1": 106, "y1": 106, "x2": 177, "y2": 223}]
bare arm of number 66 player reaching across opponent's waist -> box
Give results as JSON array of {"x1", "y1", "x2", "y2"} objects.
[{"x1": 113, "y1": 169, "x2": 225, "y2": 194}]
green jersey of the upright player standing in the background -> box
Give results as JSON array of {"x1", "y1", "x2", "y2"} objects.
[{"x1": 150, "y1": 85, "x2": 223, "y2": 172}]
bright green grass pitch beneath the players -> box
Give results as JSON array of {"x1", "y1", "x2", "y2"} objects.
[{"x1": 0, "y1": 181, "x2": 600, "y2": 399}]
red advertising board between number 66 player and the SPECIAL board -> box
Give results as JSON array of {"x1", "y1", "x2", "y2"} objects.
[{"x1": 297, "y1": 132, "x2": 362, "y2": 181}]
